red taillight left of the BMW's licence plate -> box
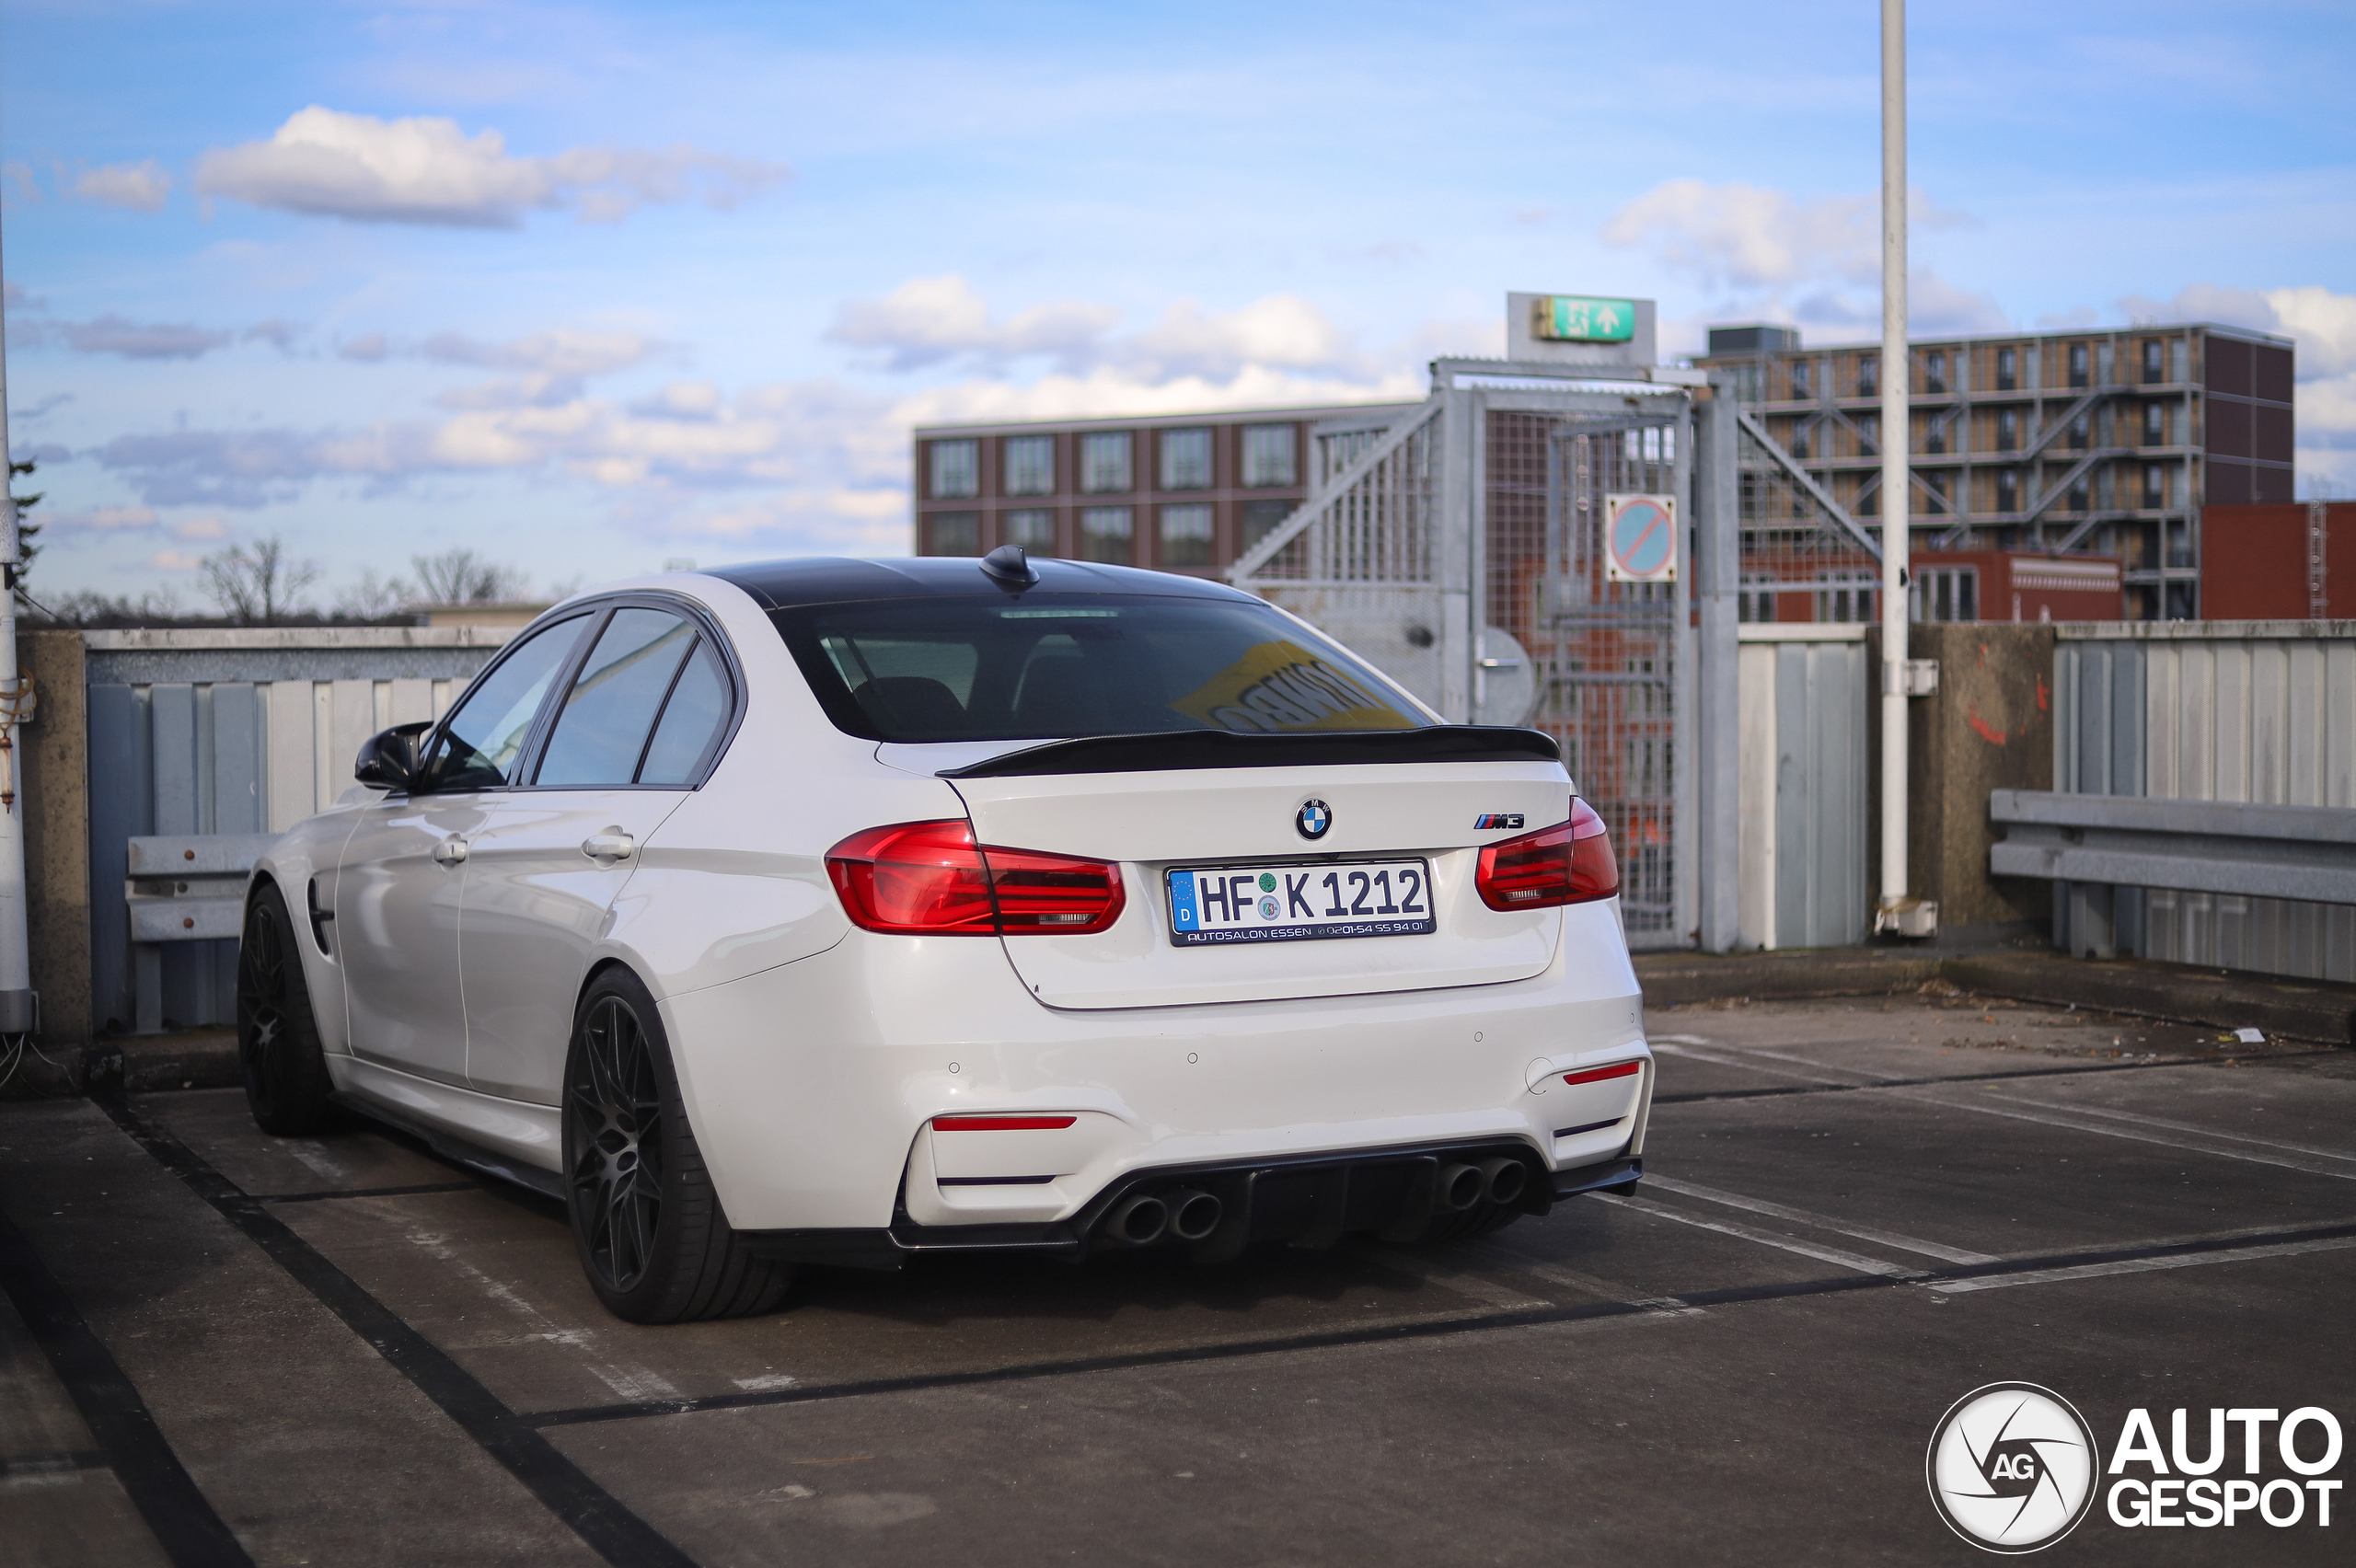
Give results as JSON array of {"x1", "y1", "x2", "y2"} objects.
[{"x1": 827, "y1": 822, "x2": 1122, "y2": 937}]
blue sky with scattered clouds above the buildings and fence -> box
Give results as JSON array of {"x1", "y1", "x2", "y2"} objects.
[{"x1": 0, "y1": 0, "x2": 2356, "y2": 610}]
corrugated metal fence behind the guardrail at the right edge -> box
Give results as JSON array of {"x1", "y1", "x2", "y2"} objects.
[{"x1": 2054, "y1": 621, "x2": 2356, "y2": 979}]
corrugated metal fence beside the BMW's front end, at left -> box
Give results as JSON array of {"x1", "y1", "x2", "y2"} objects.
[{"x1": 83, "y1": 627, "x2": 514, "y2": 1033}]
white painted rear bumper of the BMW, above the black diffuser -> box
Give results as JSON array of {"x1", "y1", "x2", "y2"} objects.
[{"x1": 662, "y1": 906, "x2": 1652, "y2": 1234}]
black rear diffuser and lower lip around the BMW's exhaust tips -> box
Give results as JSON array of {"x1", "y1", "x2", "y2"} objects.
[{"x1": 742, "y1": 1144, "x2": 1645, "y2": 1269}]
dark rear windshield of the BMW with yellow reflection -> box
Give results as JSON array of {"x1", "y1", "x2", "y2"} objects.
[{"x1": 770, "y1": 594, "x2": 1427, "y2": 742}]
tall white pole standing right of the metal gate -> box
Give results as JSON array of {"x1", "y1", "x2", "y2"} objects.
[{"x1": 1873, "y1": 0, "x2": 1927, "y2": 935}]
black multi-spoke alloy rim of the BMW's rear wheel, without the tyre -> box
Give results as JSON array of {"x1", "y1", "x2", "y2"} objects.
[{"x1": 565, "y1": 991, "x2": 662, "y2": 1295}]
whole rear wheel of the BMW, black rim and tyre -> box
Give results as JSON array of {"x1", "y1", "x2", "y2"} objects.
[{"x1": 563, "y1": 968, "x2": 794, "y2": 1323}]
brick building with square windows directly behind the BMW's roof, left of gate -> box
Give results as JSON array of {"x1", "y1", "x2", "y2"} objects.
[{"x1": 914, "y1": 403, "x2": 1416, "y2": 577}]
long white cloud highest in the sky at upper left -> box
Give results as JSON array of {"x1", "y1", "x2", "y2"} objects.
[{"x1": 195, "y1": 104, "x2": 787, "y2": 228}]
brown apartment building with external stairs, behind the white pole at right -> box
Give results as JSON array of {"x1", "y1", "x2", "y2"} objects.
[{"x1": 1696, "y1": 325, "x2": 2304, "y2": 619}]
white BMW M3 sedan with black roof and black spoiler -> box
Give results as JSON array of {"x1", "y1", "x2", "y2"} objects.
[{"x1": 238, "y1": 548, "x2": 1652, "y2": 1323}]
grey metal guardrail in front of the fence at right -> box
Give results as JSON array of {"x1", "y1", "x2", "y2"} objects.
[{"x1": 1989, "y1": 789, "x2": 2356, "y2": 904}]
